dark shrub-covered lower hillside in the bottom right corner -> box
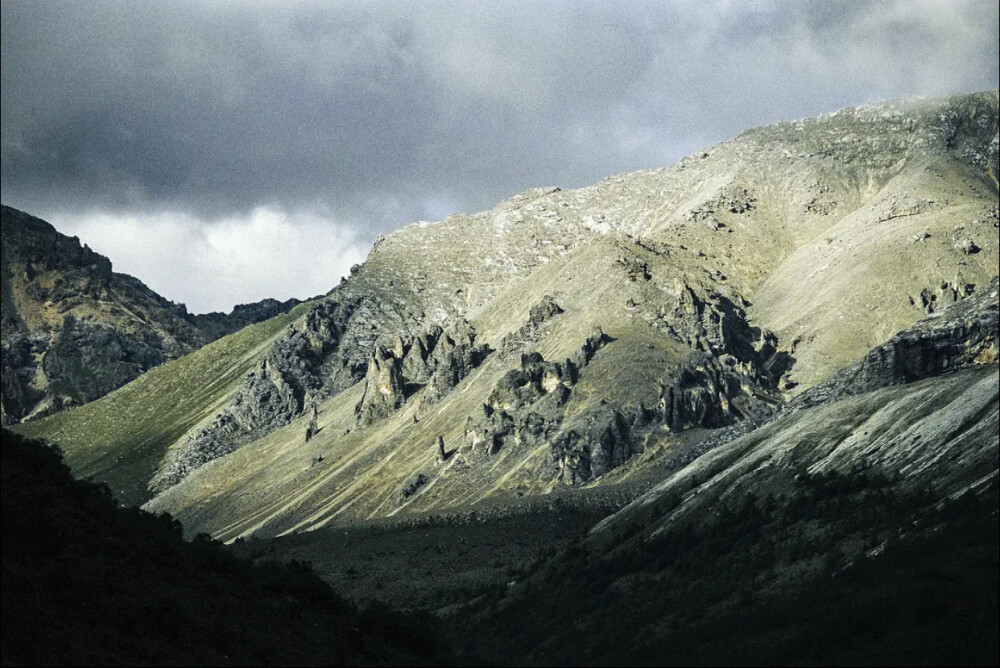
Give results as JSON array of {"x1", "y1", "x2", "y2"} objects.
[{"x1": 449, "y1": 464, "x2": 1000, "y2": 666}]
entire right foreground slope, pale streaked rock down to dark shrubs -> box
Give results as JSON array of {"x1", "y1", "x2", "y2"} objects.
[{"x1": 447, "y1": 279, "x2": 1000, "y2": 665}]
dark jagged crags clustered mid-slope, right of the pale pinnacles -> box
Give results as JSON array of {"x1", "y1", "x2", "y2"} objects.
[{"x1": 465, "y1": 284, "x2": 794, "y2": 485}]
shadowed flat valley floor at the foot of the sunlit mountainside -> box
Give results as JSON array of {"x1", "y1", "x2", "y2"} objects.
[{"x1": 230, "y1": 485, "x2": 643, "y2": 614}]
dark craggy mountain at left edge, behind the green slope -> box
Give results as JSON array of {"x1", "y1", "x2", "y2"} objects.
[{"x1": 0, "y1": 206, "x2": 299, "y2": 424}]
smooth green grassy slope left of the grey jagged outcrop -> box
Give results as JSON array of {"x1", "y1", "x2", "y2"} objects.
[{"x1": 17, "y1": 305, "x2": 308, "y2": 504}]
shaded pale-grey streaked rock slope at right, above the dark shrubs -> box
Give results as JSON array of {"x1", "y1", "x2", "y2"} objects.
[{"x1": 592, "y1": 278, "x2": 1000, "y2": 540}]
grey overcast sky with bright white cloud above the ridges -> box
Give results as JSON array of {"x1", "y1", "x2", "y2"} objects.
[{"x1": 0, "y1": 0, "x2": 998, "y2": 312}]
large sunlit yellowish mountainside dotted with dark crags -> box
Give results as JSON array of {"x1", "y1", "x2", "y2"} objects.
[{"x1": 17, "y1": 91, "x2": 1000, "y2": 539}]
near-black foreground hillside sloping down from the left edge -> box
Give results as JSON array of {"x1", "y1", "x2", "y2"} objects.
[{"x1": 0, "y1": 430, "x2": 443, "y2": 666}]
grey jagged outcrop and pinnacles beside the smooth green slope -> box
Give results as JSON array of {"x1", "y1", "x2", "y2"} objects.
[{"x1": 150, "y1": 308, "x2": 489, "y2": 493}]
